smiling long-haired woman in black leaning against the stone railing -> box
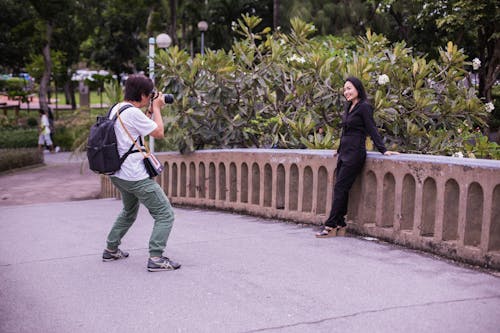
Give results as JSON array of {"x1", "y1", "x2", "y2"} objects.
[{"x1": 316, "y1": 77, "x2": 399, "y2": 238}]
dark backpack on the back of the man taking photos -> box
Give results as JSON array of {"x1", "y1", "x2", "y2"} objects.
[{"x1": 87, "y1": 104, "x2": 138, "y2": 175}]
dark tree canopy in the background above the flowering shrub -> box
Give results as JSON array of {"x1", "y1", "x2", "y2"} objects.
[{"x1": 0, "y1": 0, "x2": 500, "y2": 106}]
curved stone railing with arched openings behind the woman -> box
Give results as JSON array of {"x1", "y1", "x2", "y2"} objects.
[{"x1": 102, "y1": 149, "x2": 500, "y2": 269}]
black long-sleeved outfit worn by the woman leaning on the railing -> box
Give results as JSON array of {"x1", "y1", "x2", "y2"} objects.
[{"x1": 325, "y1": 101, "x2": 387, "y2": 228}]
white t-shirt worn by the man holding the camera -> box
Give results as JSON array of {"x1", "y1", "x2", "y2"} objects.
[{"x1": 109, "y1": 102, "x2": 158, "y2": 181}]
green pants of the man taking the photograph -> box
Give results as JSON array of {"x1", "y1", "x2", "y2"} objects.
[{"x1": 107, "y1": 177, "x2": 174, "y2": 257}]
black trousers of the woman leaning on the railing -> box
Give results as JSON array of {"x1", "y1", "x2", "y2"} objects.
[{"x1": 325, "y1": 158, "x2": 365, "y2": 228}]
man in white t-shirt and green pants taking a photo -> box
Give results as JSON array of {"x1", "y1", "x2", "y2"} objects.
[{"x1": 102, "y1": 75, "x2": 181, "y2": 272}]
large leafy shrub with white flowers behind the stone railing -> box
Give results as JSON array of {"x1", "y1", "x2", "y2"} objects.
[{"x1": 156, "y1": 15, "x2": 496, "y2": 159}]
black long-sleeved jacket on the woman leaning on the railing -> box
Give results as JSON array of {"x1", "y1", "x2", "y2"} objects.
[{"x1": 338, "y1": 101, "x2": 387, "y2": 165}]
